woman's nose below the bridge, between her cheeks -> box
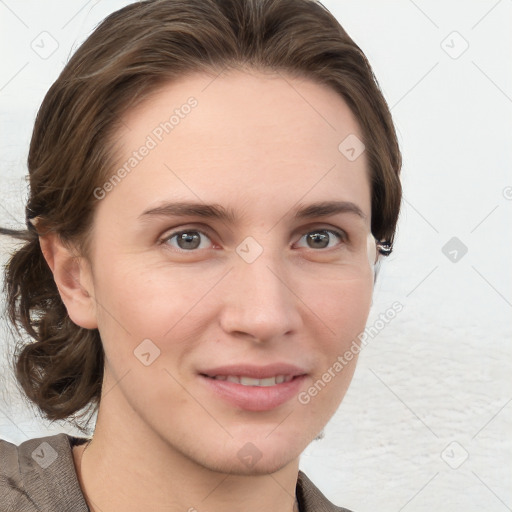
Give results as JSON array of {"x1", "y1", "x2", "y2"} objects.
[{"x1": 220, "y1": 252, "x2": 302, "y2": 342}]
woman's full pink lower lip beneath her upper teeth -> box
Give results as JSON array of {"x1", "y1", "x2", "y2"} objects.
[{"x1": 199, "y1": 375, "x2": 306, "y2": 411}]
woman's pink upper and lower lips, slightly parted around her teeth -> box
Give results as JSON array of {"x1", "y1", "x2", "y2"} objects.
[{"x1": 198, "y1": 363, "x2": 307, "y2": 412}]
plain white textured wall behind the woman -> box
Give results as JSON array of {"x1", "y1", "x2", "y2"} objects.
[{"x1": 0, "y1": 0, "x2": 512, "y2": 512}]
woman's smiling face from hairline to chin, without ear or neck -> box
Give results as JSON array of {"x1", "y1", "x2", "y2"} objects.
[{"x1": 82, "y1": 71, "x2": 375, "y2": 473}]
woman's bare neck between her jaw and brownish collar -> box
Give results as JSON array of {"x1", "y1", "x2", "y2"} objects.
[{"x1": 74, "y1": 394, "x2": 299, "y2": 512}]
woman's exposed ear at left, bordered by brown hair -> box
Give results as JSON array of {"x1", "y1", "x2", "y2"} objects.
[{"x1": 39, "y1": 232, "x2": 98, "y2": 329}]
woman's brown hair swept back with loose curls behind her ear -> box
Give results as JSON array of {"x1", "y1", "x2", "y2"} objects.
[{"x1": 0, "y1": 0, "x2": 401, "y2": 428}]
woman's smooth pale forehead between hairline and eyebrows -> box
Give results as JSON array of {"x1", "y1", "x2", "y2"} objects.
[{"x1": 101, "y1": 71, "x2": 370, "y2": 217}]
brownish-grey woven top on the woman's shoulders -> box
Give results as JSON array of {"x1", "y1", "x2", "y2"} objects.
[{"x1": 0, "y1": 433, "x2": 350, "y2": 512}]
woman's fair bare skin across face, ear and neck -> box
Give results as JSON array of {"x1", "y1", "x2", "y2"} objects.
[{"x1": 41, "y1": 70, "x2": 373, "y2": 512}]
